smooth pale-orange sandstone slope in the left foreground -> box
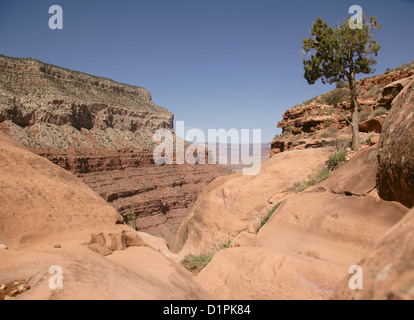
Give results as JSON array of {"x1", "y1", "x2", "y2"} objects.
[{"x1": 0, "y1": 133, "x2": 212, "y2": 300}]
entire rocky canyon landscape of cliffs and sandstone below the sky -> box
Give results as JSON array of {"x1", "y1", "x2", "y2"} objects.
[{"x1": 0, "y1": 56, "x2": 414, "y2": 300}]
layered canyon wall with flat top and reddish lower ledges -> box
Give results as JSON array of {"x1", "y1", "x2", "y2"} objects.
[{"x1": 0, "y1": 56, "x2": 230, "y2": 249}]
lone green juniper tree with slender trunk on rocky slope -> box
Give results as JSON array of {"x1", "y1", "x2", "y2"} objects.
[{"x1": 303, "y1": 17, "x2": 381, "y2": 150}]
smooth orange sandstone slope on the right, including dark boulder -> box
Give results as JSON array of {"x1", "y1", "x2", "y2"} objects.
[{"x1": 177, "y1": 62, "x2": 414, "y2": 299}]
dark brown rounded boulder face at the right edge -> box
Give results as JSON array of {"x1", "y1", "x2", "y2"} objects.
[{"x1": 377, "y1": 79, "x2": 414, "y2": 208}]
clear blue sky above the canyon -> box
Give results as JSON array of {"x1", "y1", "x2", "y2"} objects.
[{"x1": 0, "y1": 0, "x2": 414, "y2": 142}]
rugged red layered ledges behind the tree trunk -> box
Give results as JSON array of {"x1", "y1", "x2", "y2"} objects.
[{"x1": 272, "y1": 62, "x2": 414, "y2": 155}]
